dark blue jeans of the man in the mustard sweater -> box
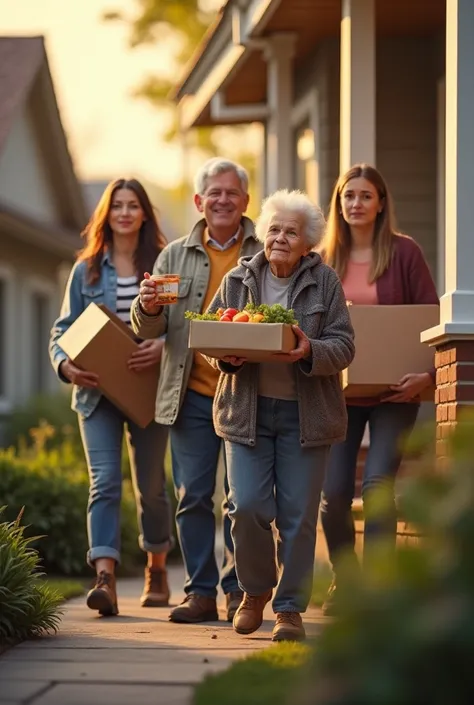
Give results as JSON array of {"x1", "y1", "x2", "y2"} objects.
[{"x1": 170, "y1": 389, "x2": 239, "y2": 597}]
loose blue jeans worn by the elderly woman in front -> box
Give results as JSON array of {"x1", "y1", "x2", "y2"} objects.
[{"x1": 225, "y1": 397, "x2": 329, "y2": 612}]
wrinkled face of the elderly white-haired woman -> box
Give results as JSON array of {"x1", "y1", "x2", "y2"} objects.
[{"x1": 265, "y1": 210, "x2": 309, "y2": 277}]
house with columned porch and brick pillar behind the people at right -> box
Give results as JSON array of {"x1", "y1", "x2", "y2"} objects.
[{"x1": 174, "y1": 0, "x2": 474, "y2": 436}]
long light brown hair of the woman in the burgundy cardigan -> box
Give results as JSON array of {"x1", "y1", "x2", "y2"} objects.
[{"x1": 318, "y1": 164, "x2": 395, "y2": 282}]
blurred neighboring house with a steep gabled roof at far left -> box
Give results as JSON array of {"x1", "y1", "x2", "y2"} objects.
[{"x1": 0, "y1": 37, "x2": 87, "y2": 418}]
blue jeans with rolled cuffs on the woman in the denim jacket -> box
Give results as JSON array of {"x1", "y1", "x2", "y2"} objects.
[{"x1": 79, "y1": 397, "x2": 173, "y2": 566}]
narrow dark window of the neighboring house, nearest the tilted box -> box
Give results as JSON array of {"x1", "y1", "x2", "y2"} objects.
[{"x1": 31, "y1": 291, "x2": 51, "y2": 394}]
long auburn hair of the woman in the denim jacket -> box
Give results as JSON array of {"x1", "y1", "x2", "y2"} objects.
[{"x1": 78, "y1": 179, "x2": 167, "y2": 284}]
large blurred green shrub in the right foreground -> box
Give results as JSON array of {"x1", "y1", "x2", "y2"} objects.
[{"x1": 298, "y1": 418, "x2": 474, "y2": 705}]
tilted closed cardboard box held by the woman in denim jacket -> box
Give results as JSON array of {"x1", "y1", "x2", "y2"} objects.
[{"x1": 58, "y1": 303, "x2": 159, "y2": 428}]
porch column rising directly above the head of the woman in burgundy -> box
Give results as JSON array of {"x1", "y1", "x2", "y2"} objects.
[{"x1": 339, "y1": 0, "x2": 376, "y2": 173}]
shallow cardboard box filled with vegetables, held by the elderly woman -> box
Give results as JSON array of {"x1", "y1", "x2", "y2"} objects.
[{"x1": 189, "y1": 321, "x2": 296, "y2": 362}]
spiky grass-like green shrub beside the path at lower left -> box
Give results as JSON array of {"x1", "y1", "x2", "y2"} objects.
[{"x1": 0, "y1": 509, "x2": 62, "y2": 644}]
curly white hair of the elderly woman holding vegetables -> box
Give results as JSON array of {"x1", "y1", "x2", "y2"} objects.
[{"x1": 255, "y1": 189, "x2": 326, "y2": 248}]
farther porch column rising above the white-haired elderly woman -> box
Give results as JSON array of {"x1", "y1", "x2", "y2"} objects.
[{"x1": 264, "y1": 33, "x2": 295, "y2": 195}]
